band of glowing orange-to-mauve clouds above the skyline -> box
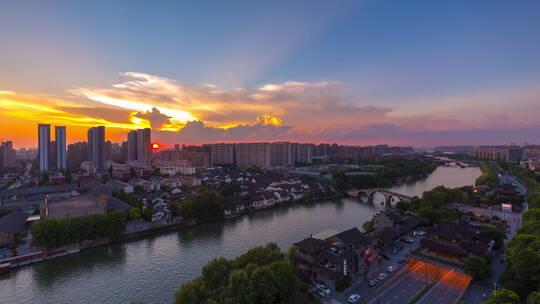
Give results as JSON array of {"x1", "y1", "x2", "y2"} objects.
[{"x1": 0, "y1": 72, "x2": 540, "y2": 147}]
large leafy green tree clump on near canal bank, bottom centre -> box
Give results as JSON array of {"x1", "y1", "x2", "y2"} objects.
[{"x1": 174, "y1": 243, "x2": 304, "y2": 304}]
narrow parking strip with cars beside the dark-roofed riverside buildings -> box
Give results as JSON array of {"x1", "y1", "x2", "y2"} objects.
[{"x1": 316, "y1": 229, "x2": 425, "y2": 303}]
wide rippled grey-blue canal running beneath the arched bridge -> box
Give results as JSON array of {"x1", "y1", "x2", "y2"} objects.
[{"x1": 0, "y1": 167, "x2": 481, "y2": 304}]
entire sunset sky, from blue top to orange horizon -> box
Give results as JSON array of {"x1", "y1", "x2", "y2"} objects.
[{"x1": 0, "y1": 0, "x2": 540, "y2": 147}]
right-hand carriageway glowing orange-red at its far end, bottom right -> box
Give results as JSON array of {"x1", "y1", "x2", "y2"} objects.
[{"x1": 416, "y1": 271, "x2": 470, "y2": 304}]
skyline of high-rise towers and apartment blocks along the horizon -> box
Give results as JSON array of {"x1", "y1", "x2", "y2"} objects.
[{"x1": 0, "y1": 124, "x2": 414, "y2": 174}]
